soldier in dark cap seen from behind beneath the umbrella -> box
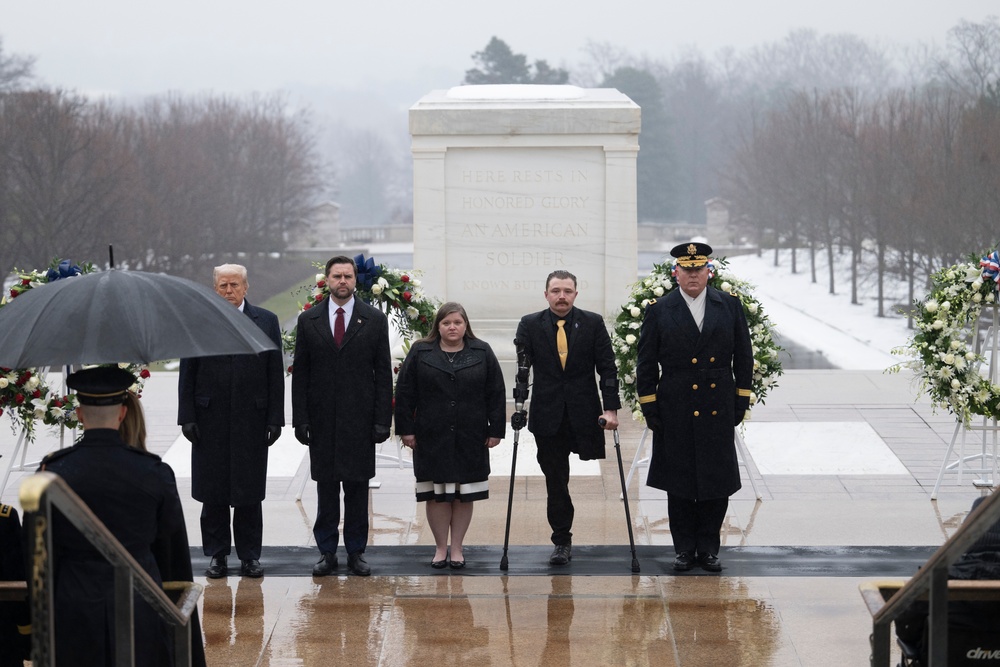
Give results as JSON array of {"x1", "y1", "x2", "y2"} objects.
[{"x1": 40, "y1": 367, "x2": 204, "y2": 667}]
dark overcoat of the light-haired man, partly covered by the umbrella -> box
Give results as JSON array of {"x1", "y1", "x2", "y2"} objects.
[{"x1": 177, "y1": 301, "x2": 285, "y2": 507}]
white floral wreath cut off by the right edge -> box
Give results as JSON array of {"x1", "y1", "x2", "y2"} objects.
[{"x1": 888, "y1": 250, "x2": 1000, "y2": 426}]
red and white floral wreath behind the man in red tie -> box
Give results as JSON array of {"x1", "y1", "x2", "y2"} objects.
[{"x1": 281, "y1": 254, "x2": 440, "y2": 373}]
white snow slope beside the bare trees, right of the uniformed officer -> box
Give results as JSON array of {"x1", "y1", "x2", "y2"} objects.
[{"x1": 727, "y1": 250, "x2": 922, "y2": 370}]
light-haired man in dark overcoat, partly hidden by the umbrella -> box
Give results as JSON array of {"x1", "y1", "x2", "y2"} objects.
[{"x1": 177, "y1": 264, "x2": 285, "y2": 579}]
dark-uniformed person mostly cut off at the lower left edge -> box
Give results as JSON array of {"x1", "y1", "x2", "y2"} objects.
[{"x1": 0, "y1": 504, "x2": 31, "y2": 667}]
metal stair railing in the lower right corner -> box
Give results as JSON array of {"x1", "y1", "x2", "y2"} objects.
[{"x1": 861, "y1": 493, "x2": 1000, "y2": 667}]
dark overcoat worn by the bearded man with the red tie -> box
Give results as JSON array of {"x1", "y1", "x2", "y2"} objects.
[{"x1": 292, "y1": 299, "x2": 392, "y2": 482}]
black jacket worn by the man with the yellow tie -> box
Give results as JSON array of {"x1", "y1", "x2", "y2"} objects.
[{"x1": 517, "y1": 308, "x2": 622, "y2": 461}]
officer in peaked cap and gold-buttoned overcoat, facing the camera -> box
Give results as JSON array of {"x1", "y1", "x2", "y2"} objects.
[{"x1": 636, "y1": 243, "x2": 753, "y2": 572}]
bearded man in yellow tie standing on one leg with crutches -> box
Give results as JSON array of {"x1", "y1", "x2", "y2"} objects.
[{"x1": 516, "y1": 270, "x2": 621, "y2": 565}]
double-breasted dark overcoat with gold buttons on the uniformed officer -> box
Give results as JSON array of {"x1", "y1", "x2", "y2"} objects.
[{"x1": 636, "y1": 287, "x2": 753, "y2": 500}]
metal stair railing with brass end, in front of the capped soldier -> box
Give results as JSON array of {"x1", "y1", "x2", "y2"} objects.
[{"x1": 20, "y1": 472, "x2": 202, "y2": 667}]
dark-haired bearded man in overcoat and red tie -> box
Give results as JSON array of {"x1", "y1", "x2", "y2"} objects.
[{"x1": 292, "y1": 256, "x2": 392, "y2": 577}]
